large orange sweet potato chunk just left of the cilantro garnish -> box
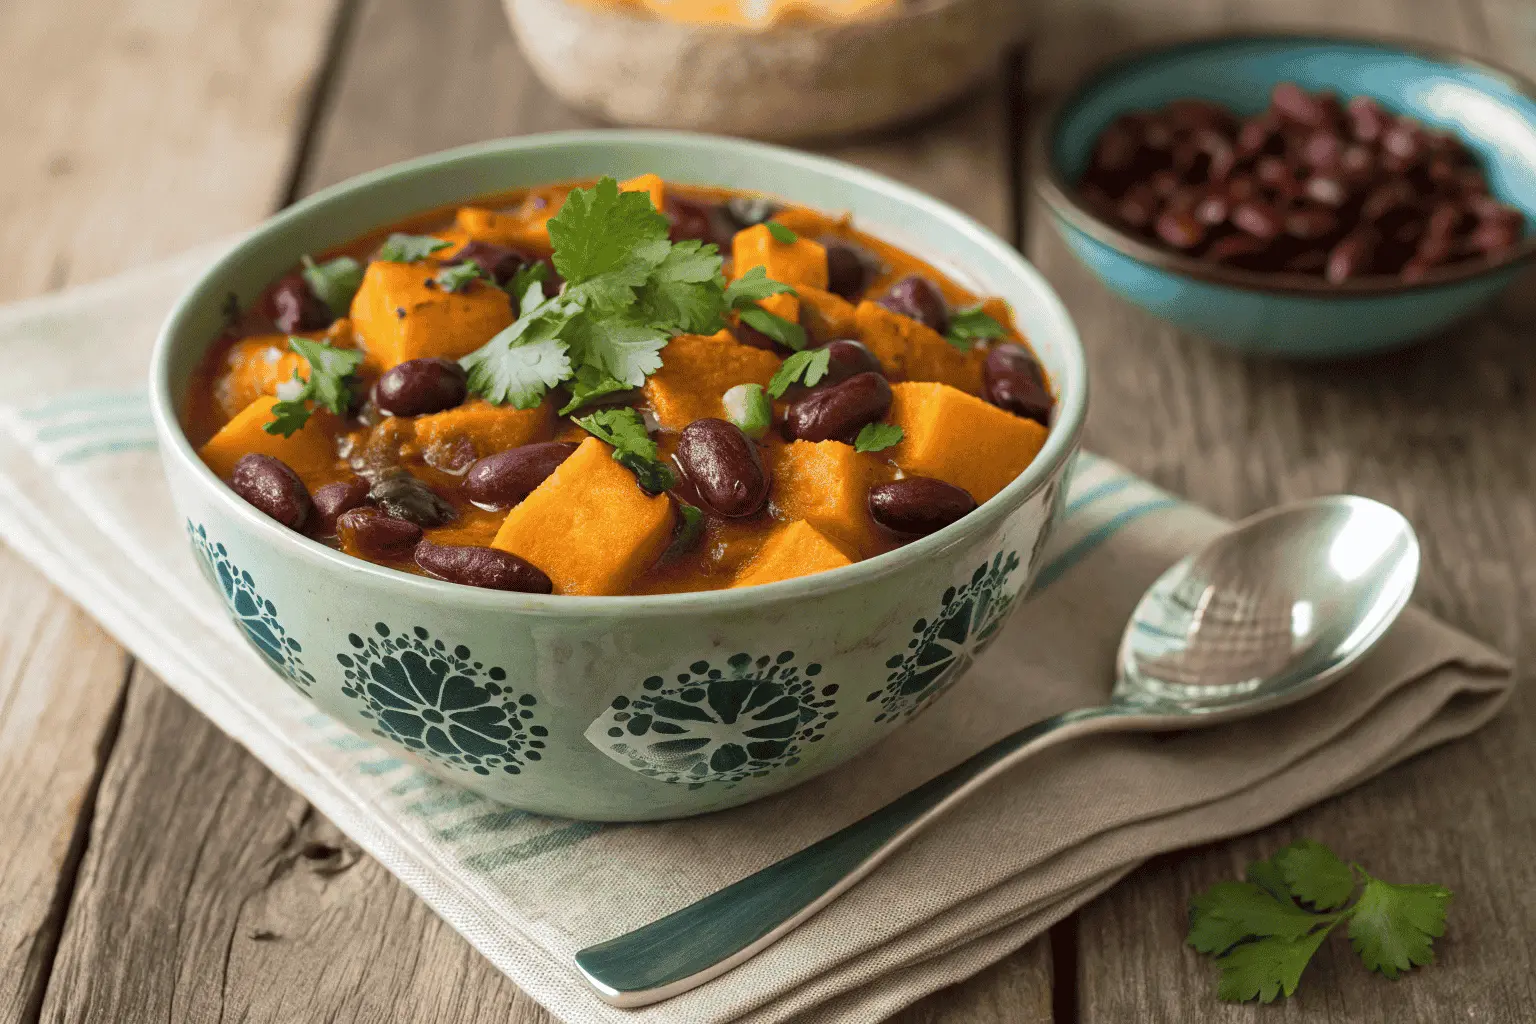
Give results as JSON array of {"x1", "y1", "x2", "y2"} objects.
[{"x1": 352, "y1": 259, "x2": 513, "y2": 372}]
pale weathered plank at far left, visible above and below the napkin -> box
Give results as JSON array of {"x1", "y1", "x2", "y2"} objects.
[{"x1": 0, "y1": 0, "x2": 342, "y2": 1021}]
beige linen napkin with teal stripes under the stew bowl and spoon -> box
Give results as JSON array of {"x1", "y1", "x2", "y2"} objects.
[{"x1": 0, "y1": 247, "x2": 1511, "y2": 1024}]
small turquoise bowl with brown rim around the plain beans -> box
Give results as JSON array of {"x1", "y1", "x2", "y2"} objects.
[{"x1": 1037, "y1": 35, "x2": 1536, "y2": 359}]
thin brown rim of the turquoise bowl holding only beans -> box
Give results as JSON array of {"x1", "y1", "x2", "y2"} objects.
[{"x1": 1031, "y1": 28, "x2": 1536, "y2": 298}]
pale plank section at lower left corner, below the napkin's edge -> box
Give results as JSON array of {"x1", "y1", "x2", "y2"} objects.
[{"x1": 0, "y1": 548, "x2": 127, "y2": 1021}]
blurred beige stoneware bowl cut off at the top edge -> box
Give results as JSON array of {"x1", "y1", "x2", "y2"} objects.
[{"x1": 504, "y1": 0, "x2": 1029, "y2": 140}]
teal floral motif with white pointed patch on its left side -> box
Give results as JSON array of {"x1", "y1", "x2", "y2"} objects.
[{"x1": 587, "y1": 651, "x2": 837, "y2": 789}]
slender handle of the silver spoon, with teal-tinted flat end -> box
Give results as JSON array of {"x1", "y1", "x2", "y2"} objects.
[{"x1": 576, "y1": 706, "x2": 1138, "y2": 1007}]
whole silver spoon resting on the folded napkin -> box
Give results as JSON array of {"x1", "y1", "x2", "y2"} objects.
[{"x1": 576, "y1": 496, "x2": 1419, "y2": 1007}]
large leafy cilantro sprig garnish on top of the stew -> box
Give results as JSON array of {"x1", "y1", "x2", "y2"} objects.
[{"x1": 461, "y1": 178, "x2": 803, "y2": 415}]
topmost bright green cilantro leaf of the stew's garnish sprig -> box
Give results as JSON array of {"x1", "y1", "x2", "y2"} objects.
[{"x1": 548, "y1": 177, "x2": 668, "y2": 286}]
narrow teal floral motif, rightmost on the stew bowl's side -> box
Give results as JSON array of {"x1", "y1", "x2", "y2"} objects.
[{"x1": 866, "y1": 551, "x2": 1018, "y2": 722}]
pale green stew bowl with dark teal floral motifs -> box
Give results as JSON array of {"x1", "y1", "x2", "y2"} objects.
[{"x1": 151, "y1": 132, "x2": 1087, "y2": 820}]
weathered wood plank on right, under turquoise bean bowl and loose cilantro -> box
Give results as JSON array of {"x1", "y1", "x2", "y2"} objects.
[{"x1": 1028, "y1": 0, "x2": 1536, "y2": 1024}]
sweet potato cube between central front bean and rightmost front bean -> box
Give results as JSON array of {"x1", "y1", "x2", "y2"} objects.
[{"x1": 768, "y1": 441, "x2": 880, "y2": 557}]
